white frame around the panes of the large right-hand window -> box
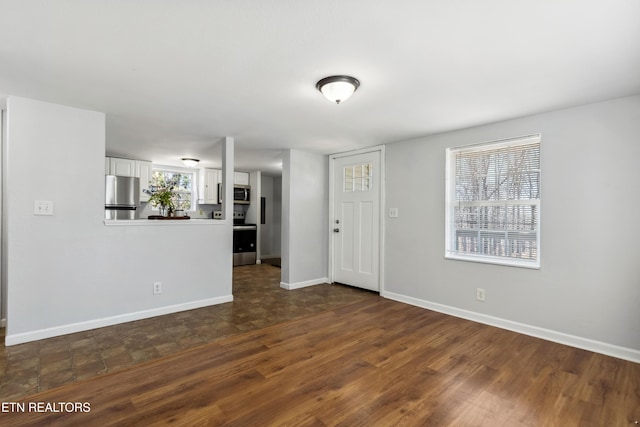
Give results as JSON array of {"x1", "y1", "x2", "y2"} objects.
[{"x1": 445, "y1": 134, "x2": 542, "y2": 269}]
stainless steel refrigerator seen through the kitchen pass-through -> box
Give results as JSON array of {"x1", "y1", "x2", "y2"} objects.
[{"x1": 104, "y1": 175, "x2": 140, "y2": 219}]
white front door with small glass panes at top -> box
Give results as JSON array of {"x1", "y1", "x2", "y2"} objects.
[{"x1": 331, "y1": 151, "x2": 382, "y2": 291}]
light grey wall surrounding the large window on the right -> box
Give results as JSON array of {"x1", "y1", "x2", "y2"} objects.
[{"x1": 385, "y1": 96, "x2": 640, "y2": 361}]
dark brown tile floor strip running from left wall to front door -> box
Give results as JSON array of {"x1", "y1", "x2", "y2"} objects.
[{"x1": 0, "y1": 264, "x2": 378, "y2": 402}]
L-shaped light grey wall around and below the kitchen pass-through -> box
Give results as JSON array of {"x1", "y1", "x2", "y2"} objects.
[{"x1": 5, "y1": 97, "x2": 233, "y2": 344}]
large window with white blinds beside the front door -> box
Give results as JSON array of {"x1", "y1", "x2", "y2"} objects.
[{"x1": 445, "y1": 135, "x2": 540, "y2": 268}]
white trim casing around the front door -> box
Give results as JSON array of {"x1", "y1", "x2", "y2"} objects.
[{"x1": 329, "y1": 145, "x2": 386, "y2": 294}]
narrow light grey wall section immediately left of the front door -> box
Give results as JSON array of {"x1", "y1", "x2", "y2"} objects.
[{"x1": 282, "y1": 150, "x2": 329, "y2": 289}]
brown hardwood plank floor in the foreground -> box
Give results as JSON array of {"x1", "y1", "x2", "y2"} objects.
[{"x1": 0, "y1": 298, "x2": 640, "y2": 427}]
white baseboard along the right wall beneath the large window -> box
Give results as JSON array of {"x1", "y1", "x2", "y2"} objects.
[{"x1": 380, "y1": 292, "x2": 640, "y2": 363}]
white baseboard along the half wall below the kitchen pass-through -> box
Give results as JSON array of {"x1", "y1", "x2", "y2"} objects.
[{"x1": 4, "y1": 295, "x2": 233, "y2": 346}]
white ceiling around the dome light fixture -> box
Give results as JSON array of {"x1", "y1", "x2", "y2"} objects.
[{"x1": 0, "y1": 0, "x2": 640, "y2": 174}]
